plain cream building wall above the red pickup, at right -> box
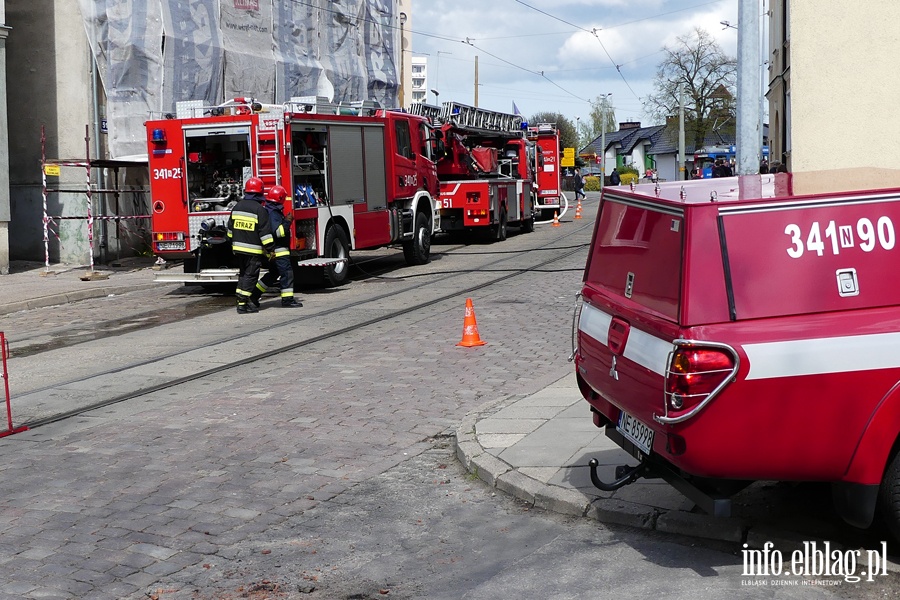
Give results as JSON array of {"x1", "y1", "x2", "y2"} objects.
[{"x1": 766, "y1": 0, "x2": 900, "y2": 193}]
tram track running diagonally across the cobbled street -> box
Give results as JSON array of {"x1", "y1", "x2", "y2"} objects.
[{"x1": 8, "y1": 223, "x2": 592, "y2": 429}]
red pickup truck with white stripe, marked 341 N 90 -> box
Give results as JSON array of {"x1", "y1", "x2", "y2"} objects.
[{"x1": 573, "y1": 174, "x2": 900, "y2": 539}]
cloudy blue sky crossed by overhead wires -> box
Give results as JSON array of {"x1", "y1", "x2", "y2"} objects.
[{"x1": 407, "y1": 0, "x2": 744, "y2": 131}]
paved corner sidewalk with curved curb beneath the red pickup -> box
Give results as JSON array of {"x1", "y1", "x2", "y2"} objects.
[{"x1": 456, "y1": 367, "x2": 897, "y2": 556}]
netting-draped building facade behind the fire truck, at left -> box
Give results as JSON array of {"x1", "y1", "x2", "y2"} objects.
[{"x1": 0, "y1": 0, "x2": 411, "y2": 265}]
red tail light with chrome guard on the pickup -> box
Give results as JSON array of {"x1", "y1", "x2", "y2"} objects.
[{"x1": 654, "y1": 340, "x2": 739, "y2": 424}]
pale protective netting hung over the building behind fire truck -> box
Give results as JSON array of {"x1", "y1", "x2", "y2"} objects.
[{"x1": 79, "y1": 0, "x2": 400, "y2": 158}]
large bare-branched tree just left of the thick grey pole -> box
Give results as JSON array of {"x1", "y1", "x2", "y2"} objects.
[{"x1": 645, "y1": 27, "x2": 737, "y2": 148}]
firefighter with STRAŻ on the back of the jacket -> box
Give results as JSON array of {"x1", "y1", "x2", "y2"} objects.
[{"x1": 228, "y1": 177, "x2": 274, "y2": 314}]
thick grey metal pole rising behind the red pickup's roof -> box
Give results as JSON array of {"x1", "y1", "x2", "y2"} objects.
[{"x1": 736, "y1": 0, "x2": 760, "y2": 175}]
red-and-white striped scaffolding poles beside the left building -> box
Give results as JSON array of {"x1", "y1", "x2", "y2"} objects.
[{"x1": 41, "y1": 125, "x2": 150, "y2": 274}]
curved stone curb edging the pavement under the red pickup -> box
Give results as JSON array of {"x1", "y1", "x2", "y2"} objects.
[{"x1": 454, "y1": 398, "x2": 900, "y2": 573}]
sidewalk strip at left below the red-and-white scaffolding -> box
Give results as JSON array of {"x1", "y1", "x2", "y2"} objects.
[{"x1": 0, "y1": 257, "x2": 160, "y2": 316}]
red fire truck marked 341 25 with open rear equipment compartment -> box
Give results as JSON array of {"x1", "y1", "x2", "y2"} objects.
[{"x1": 146, "y1": 97, "x2": 440, "y2": 285}]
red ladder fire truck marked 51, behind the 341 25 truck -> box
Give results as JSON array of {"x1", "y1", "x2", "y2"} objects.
[{"x1": 411, "y1": 102, "x2": 536, "y2": 241}]
